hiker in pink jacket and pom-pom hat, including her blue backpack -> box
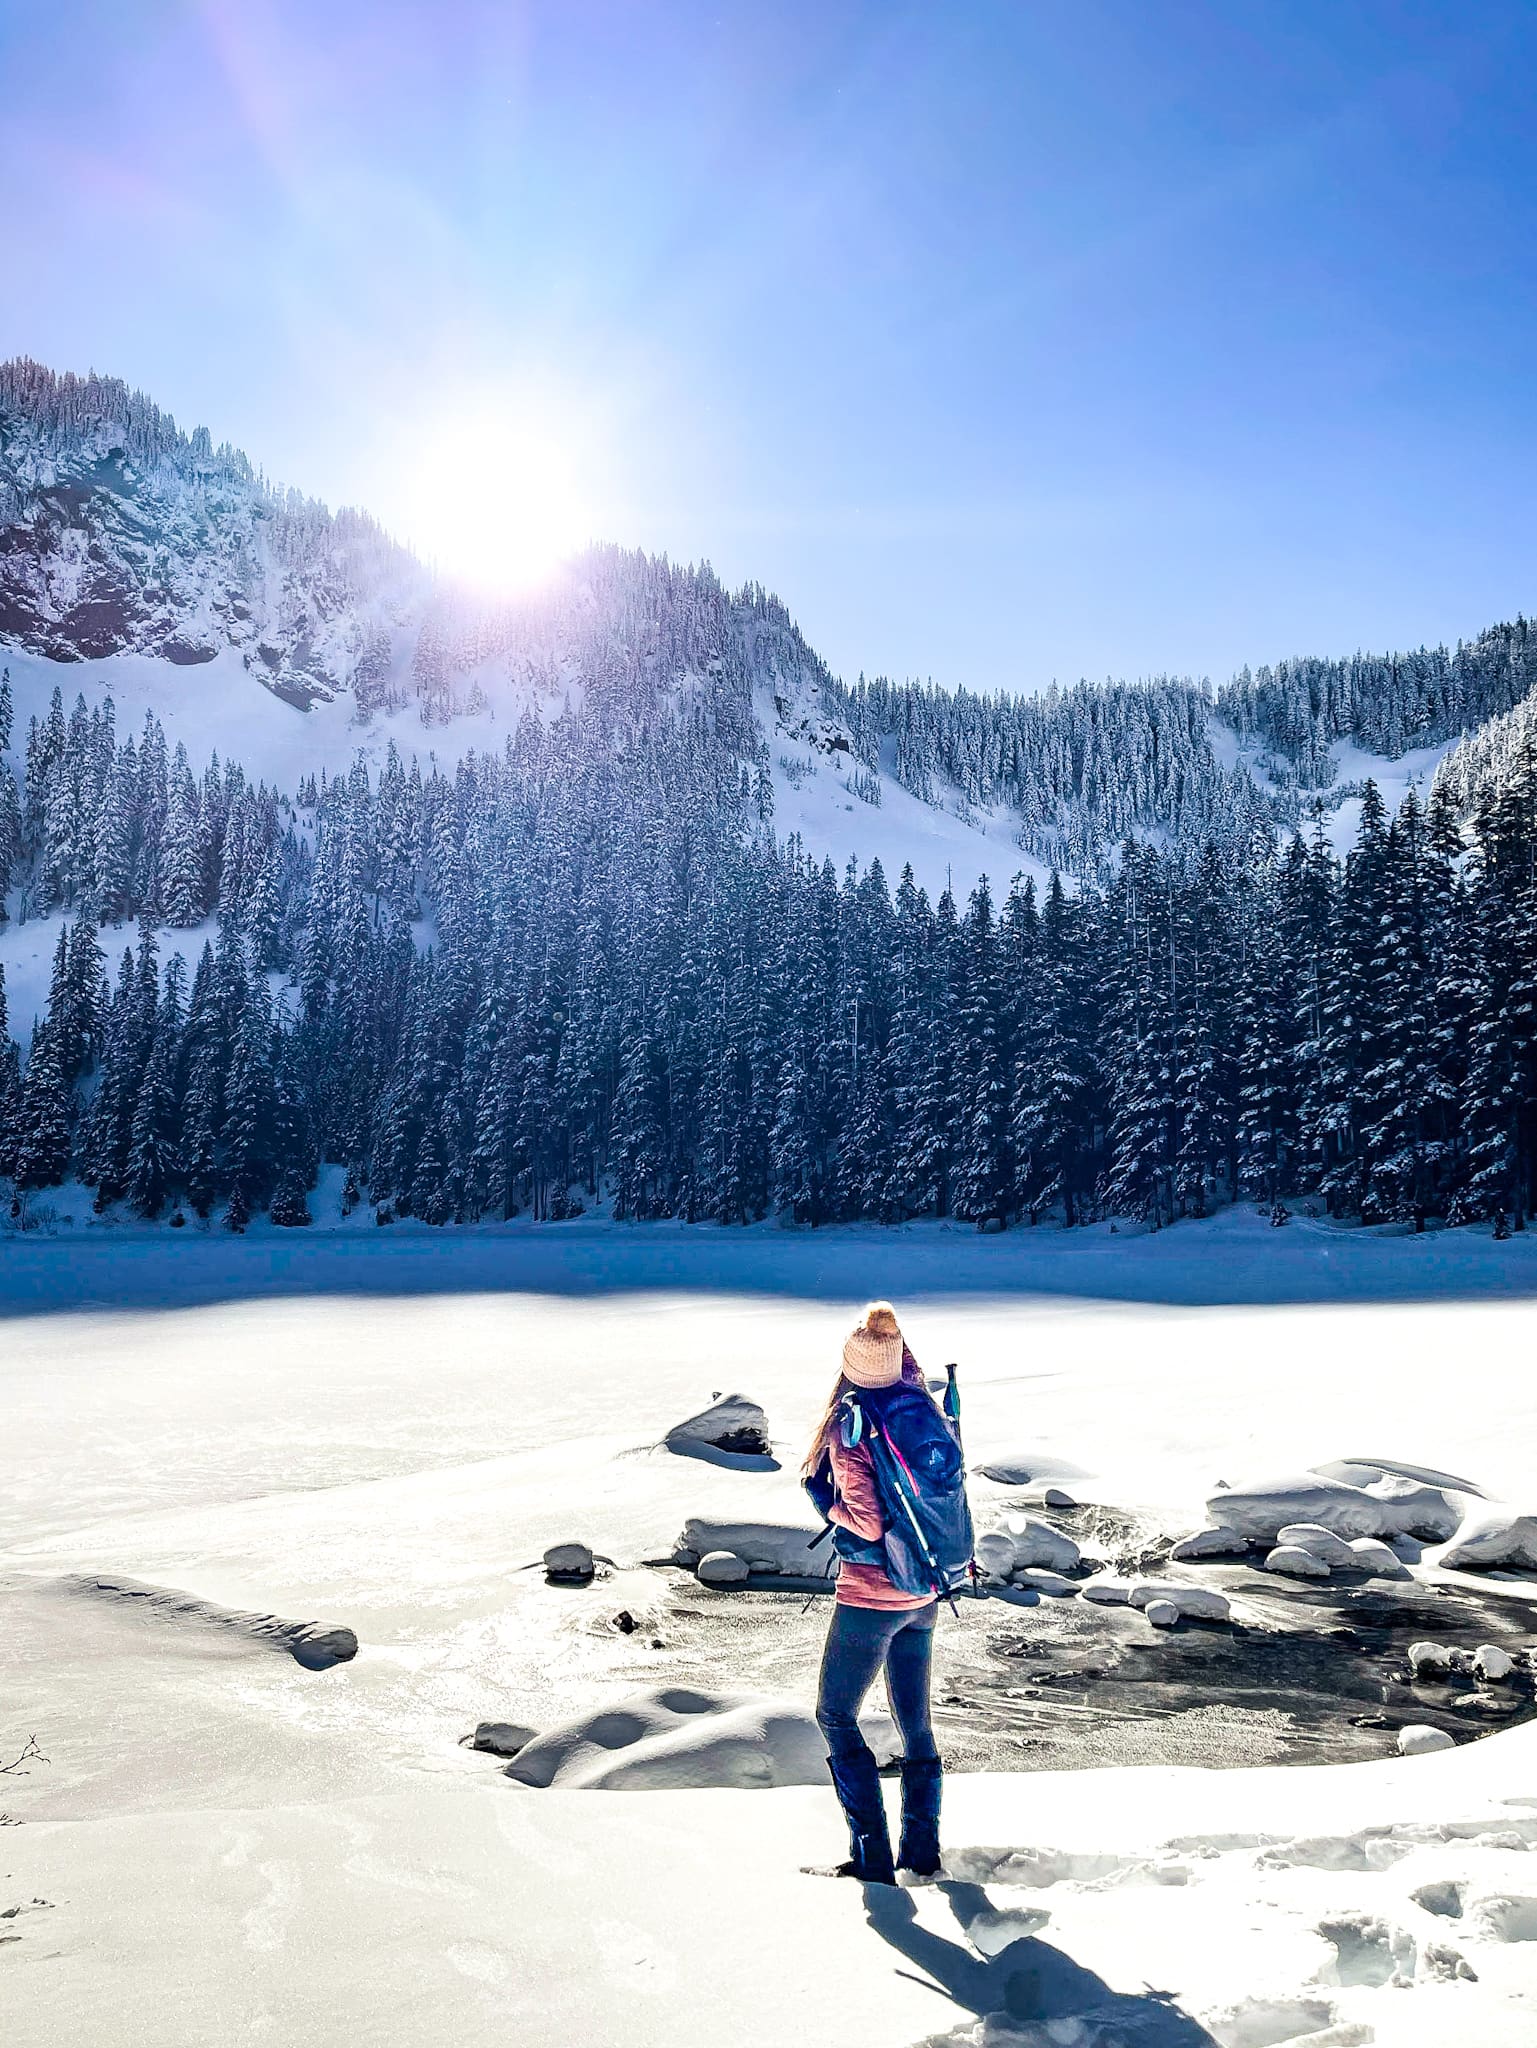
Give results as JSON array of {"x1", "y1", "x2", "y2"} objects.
[{"x1": 801, "y1": 1300, "x2": 971, "y2": 1884}]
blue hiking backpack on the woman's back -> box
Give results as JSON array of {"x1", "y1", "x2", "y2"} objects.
[{"x1": 805, "y1": 1376, "x2": 971, "y2": 1597}]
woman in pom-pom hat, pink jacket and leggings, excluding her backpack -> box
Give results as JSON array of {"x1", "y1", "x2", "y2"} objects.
[{"x1": 801, "y1": 1300, "x2": 941, "y2": 1884}]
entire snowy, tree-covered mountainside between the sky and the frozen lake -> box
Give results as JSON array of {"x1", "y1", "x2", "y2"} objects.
[{"x1": 0, "y1": 365, "x2": 1537, "y2": 1229}]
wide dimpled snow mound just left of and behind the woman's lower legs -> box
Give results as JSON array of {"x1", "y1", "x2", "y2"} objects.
[{"x1": 506, "y1": 1686, "x2": 900, "y2": 1792}]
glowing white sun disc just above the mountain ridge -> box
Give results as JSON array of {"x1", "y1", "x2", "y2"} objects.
[{"x1": 404, "y1": 399, "x2": 594, "y2": 596}]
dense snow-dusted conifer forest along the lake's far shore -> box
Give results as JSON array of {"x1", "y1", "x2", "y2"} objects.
[{"x1": 0, "y1": 610, "x2": 1537, "y2": 1229}]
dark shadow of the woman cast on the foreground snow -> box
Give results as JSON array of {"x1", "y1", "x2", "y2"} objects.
[{"x1": 865, "y1": 1880, "x2": 1217, "y2": 2048}]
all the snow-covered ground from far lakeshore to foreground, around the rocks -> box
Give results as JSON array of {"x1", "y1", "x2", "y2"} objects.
[{"x1": 0, "y1": 1212, "x2": 1537, "y2": 2048}]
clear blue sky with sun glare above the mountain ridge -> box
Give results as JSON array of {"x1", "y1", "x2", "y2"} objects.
[{"x1": 0, "y1": 0, "x2": 1537, "y2": 688}]
